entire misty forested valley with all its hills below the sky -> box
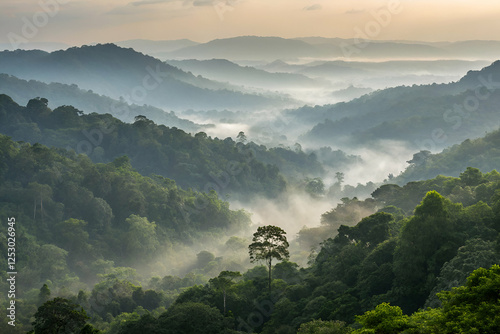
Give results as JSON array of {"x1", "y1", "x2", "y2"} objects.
[{"x1": 0, "y1": 36, "x2": 500, "y2": 334}]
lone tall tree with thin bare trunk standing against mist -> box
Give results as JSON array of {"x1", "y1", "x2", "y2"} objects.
[{"x1": 248, "y1": 225, "x2": 290, "y2": 294}]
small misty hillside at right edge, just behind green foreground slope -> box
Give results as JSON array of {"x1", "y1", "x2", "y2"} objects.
[{"x1": 391, "y1": 127, "x2": 500, "y2": 185}]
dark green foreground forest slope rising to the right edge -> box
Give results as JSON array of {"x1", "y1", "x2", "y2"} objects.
[{"x1": 77, "y1": 168, "x2": 500, "y2": 334}]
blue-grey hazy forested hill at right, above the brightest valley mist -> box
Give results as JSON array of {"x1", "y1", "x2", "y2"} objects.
[{"x1": 294, "y1": 62, "x2": 500, "y2": 150}]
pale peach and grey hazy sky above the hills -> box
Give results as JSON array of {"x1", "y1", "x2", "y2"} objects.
[{"x1": 0, "y1": 0, "x2": 500, "y2": 45}]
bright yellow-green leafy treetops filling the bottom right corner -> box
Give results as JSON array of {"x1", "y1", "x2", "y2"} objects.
[{"x1": 355, "y1": 265, "x2": 500, "y2": 334}]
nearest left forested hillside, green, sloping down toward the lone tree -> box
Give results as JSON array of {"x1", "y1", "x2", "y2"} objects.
[{"x1": 0, "y1": 133, "x2": 250, "y2": 310}]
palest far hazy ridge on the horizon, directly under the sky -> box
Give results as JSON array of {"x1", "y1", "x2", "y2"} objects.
[{"x1": 162, "y1": 36, "x2": 500, "y2": 62}]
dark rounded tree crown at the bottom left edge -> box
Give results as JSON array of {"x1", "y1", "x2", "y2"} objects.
[{"x1": 32, "y1": 297, "x2": 89, "y2": 334}]
